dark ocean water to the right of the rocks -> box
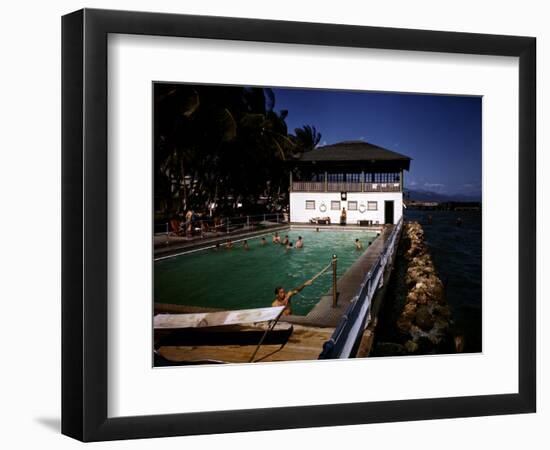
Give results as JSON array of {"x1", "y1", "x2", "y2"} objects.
[{"x1": 405, "y1": 210, "x2": 482, "y2": 352}]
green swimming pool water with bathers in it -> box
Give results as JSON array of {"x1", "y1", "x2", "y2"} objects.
[{"x1": 154, "y1": 230, "x2": 376, "y2": 315}]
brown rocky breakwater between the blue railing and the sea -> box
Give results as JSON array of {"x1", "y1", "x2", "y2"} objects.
[{"x1": 396, "y1": 222, "x2": 452, "y2": 354}]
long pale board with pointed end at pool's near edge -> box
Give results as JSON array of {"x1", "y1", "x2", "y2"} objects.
[{"x1": 153, "y1": 306, "x2": 285, "y2": 330}]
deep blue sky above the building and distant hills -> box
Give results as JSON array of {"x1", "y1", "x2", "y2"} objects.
[{"x1": 273, "y1": 88, "x2": 481, "y2": 195}]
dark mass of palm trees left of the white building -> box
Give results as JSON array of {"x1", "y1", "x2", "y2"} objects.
[{"x1": 154, "y1": 84, "x2": 321, "y2": 218}]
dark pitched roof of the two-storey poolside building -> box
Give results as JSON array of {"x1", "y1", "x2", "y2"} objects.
[{"x1": 299, "y1": 141, "x2": 411, "y2": 169}]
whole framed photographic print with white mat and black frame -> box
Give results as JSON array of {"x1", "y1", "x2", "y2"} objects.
[{"x1": 62, "y1": 9, "x2": 536, "y2": 441}]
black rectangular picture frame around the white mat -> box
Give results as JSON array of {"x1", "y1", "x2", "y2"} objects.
[{"x1": 62, "y1": 9, "x2": 536, "y2": 441}]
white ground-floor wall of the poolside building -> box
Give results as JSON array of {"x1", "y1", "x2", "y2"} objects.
[{"x1": 290, "y1": 192, "x2": 403, "y2": 225}]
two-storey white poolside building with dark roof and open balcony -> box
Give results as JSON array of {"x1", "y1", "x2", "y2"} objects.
[{"x1": 290, "y1": 141, "x2": 411, "y2": 225}]
